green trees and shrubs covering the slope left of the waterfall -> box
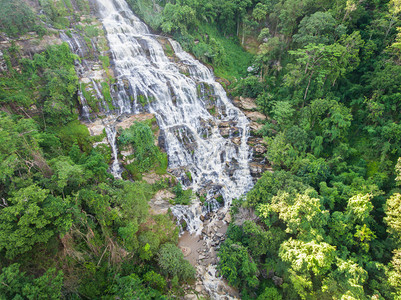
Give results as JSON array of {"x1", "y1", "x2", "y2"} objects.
[{"x1": 0, "y1": 1, "x2": 195, "y2": 299}]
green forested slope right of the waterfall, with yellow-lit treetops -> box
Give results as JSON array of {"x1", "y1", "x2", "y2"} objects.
[{"x1": 127, "y1": 0, "x2": 401, "y2": 299}]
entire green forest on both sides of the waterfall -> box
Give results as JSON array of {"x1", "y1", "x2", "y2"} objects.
[{"x1": 0, "y1": 0, "x2": 401, "y2": 300}]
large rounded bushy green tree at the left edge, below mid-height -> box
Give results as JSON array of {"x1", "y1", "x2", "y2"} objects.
[{"x1": 0, "y1": 185, "x2": 72, "y2": 258}]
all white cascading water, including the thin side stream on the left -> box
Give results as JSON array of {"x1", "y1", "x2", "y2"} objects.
[{"x1": 65, "y1": 0, "x2": 253, "y2": 298}]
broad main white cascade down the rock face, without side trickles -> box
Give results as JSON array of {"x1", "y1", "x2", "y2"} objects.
[{"x1": 97, "y1": 0, "x2": 252, "y2": 209}]
